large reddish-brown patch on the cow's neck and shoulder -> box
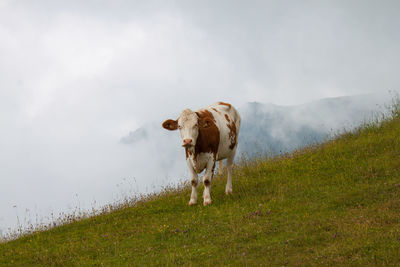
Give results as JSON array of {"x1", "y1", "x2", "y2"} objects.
[{"x1": 194, "y1": 110, "x2": 220, "y2": 160}]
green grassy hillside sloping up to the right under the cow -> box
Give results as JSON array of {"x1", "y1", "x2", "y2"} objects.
[{"x1": 0, "y1": 108, "x2": 400, "y2": 266}]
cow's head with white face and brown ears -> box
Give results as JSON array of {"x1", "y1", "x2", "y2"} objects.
[{"x1": 162, "y1": 109, "x2": 212, "y2": 148}]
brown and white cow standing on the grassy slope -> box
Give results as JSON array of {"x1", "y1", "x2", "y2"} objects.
[{"x1": 162, "y1": 102, "x2": 240, "y2": 206}]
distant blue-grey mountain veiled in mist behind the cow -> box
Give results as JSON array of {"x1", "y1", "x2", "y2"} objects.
[{"x1": 121, "y1": 94, "x2": 389, "y2": 159}]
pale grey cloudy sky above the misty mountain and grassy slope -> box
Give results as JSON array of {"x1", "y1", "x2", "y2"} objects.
[{"x1": 0, "y1": 0, "x2": 400, "y2": 237}]
